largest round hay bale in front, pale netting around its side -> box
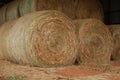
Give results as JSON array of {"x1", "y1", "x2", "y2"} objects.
[{"x1": 2, "y1": 10, "x2": 76, "y2": 67}]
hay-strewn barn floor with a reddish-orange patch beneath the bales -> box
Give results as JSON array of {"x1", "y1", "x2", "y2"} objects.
[{"x1": 0, "y1": 60, "x2": 120, "y2": 80}]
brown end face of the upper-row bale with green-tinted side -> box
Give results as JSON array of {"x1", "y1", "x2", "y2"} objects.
[{"x1": 36, "y1": 0, "x2": 75, "y2": 19}]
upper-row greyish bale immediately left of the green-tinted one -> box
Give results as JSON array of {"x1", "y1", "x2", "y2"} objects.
[{"x1": 6, "y1": 0, "x2": 19, "y2": 21}]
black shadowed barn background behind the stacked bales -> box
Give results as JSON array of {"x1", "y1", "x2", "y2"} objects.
[{"x1": 0, "y1": 0, "x2": 120, "y2": 24}]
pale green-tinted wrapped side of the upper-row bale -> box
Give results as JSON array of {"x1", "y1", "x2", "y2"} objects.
[{"x1": 19, "y1": 0, "x2": 36, "y2": 16}]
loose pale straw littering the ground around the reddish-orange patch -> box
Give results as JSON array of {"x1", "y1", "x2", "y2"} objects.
[{"x1": 0, "y1": 61, "x2": 120, "y2": 80}]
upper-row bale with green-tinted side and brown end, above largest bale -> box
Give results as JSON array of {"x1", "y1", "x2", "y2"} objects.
[{"x1": 19, "y1": 0, "x2": 75, "y2": 19}]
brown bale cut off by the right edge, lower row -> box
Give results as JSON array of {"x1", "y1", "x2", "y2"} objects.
[{"x1": 108, "y1": 25, "x2": 120, "y2": 60}]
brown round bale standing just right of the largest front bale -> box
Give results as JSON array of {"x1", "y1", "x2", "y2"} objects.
[{"x1": 74, "y1": 19, "x2": 113, "y2": 64}]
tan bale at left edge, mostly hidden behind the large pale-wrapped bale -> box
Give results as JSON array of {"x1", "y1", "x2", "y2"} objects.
[{"x1": 0, "y1": 21, "x2": 16, "y2": 59}]
